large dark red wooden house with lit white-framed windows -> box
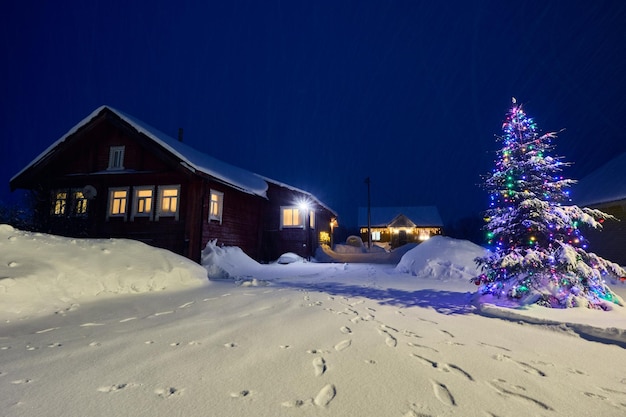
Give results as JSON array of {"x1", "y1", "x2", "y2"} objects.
[{"x1": 10, "y1": 106, "x2": 337, "y2": 261}]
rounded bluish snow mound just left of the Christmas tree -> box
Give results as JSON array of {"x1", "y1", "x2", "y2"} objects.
[{"x1": 395, "y1": 236, "x2": 487, "y2": 281}]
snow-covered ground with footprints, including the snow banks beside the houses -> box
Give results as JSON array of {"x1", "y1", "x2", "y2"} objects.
[{"x1": 0, "y1": 225, "x2": 626, "y2": 417}]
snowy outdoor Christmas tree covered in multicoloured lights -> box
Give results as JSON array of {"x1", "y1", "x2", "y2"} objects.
[{"x1": 473, "y1": 99, "x2": 626, "y2": 309}]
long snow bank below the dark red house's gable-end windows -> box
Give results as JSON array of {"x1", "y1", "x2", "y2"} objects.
[{"x1": 0, "y1": 225, "x2": 207, "y2": 315}]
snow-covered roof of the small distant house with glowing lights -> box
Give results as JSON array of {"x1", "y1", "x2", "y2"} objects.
[{"x1": 358, "y1": 206, "x2": 443, "y2": 227}]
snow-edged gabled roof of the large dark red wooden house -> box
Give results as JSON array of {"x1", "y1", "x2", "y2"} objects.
[{"x1": 11, "y1": 105, "x2": 337, "y2": 215}]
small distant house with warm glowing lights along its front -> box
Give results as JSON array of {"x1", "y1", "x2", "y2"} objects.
[{"x1": 358, "y1": 206, "x2": 443, "y2": 248}]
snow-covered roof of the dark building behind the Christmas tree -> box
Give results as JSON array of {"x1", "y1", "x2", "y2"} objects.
[{"x1": 571, "y1": 153, "x2": 626, "y2": 206}]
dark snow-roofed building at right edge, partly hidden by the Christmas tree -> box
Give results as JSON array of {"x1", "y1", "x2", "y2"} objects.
[{"x1": 572, "y1": 153, "x2": 626, "y2": 265}]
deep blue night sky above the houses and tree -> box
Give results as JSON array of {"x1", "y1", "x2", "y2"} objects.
[{"x1": 0, "y1": 0, "x2": 626, "y2": 226}]
